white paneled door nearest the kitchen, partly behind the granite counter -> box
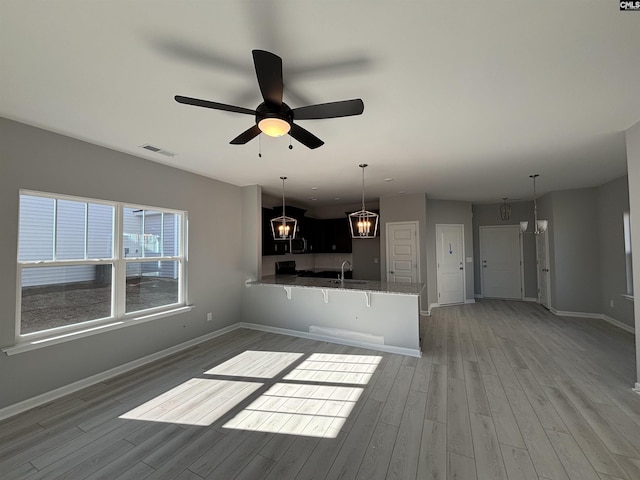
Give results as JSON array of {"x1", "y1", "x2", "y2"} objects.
[{"x1": 386, "y1": 222, "x2": 420, "y2": 283}]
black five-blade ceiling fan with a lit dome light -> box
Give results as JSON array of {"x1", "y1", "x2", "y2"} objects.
[{"x1": 175, "y1": 50, "x2": 364, "y2": 149}]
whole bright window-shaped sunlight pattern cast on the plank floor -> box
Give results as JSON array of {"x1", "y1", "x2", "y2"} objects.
[{"x1": 120, "y1": 350, "x2": 382, "y2": 438}]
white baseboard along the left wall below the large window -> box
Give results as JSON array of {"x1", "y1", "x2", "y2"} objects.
[{"x1": 0, "y1": 324, "x2": 239, "y2": 420}]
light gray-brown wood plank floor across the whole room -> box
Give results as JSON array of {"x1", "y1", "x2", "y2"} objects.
[{"x1": 0, "y1": 301, "x2": 640, "y2": 480}]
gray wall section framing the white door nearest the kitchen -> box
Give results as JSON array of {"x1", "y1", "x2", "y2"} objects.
[{"x1": 380, "y1": 193, "x2": 429, "y2": 310}]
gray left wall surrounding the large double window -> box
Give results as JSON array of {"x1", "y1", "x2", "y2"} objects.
[{"x1": 0, "y1": 118, "x2": 248, "y2": 408}]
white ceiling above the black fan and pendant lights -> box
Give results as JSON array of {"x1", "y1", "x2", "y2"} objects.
[{"x1": 0, "y1": 0, "x2": 640, "y2": 206}]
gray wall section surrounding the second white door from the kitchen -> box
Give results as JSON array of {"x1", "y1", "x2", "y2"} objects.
[{"x1": 426, "y1": 199, "x2": 474, "y2": 305}]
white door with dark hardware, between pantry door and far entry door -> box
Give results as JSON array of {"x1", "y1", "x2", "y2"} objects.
[{"x1": 436, "y1": 225, "x2": 466, "y2": 305}]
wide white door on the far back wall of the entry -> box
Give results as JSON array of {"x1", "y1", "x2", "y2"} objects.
[{"x1": 480, "y1": 225, "x2": 522, "y2": 300}]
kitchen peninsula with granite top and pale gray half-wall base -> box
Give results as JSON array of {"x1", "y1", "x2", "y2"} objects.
[{"x1": 243, "y1": 275, "x2": 424, "y2": 356}]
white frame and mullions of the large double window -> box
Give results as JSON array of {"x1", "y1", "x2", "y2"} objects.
[{"x1": 15, "y1": 189, "x2": 188, "y2": 345}]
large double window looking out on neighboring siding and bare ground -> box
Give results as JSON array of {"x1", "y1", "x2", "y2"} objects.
[{"x1": 17, "y1": 191, "x2": 186, "y2": 337}]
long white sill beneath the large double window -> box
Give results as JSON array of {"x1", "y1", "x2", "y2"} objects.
[{"x1": 2, "y1": 305, "x2": 193, "y2": 356}]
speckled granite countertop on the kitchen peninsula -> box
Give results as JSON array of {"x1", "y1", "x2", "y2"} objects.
[{"x1": 247, "y1": 275, "x2": 425, "y2": 295}]
